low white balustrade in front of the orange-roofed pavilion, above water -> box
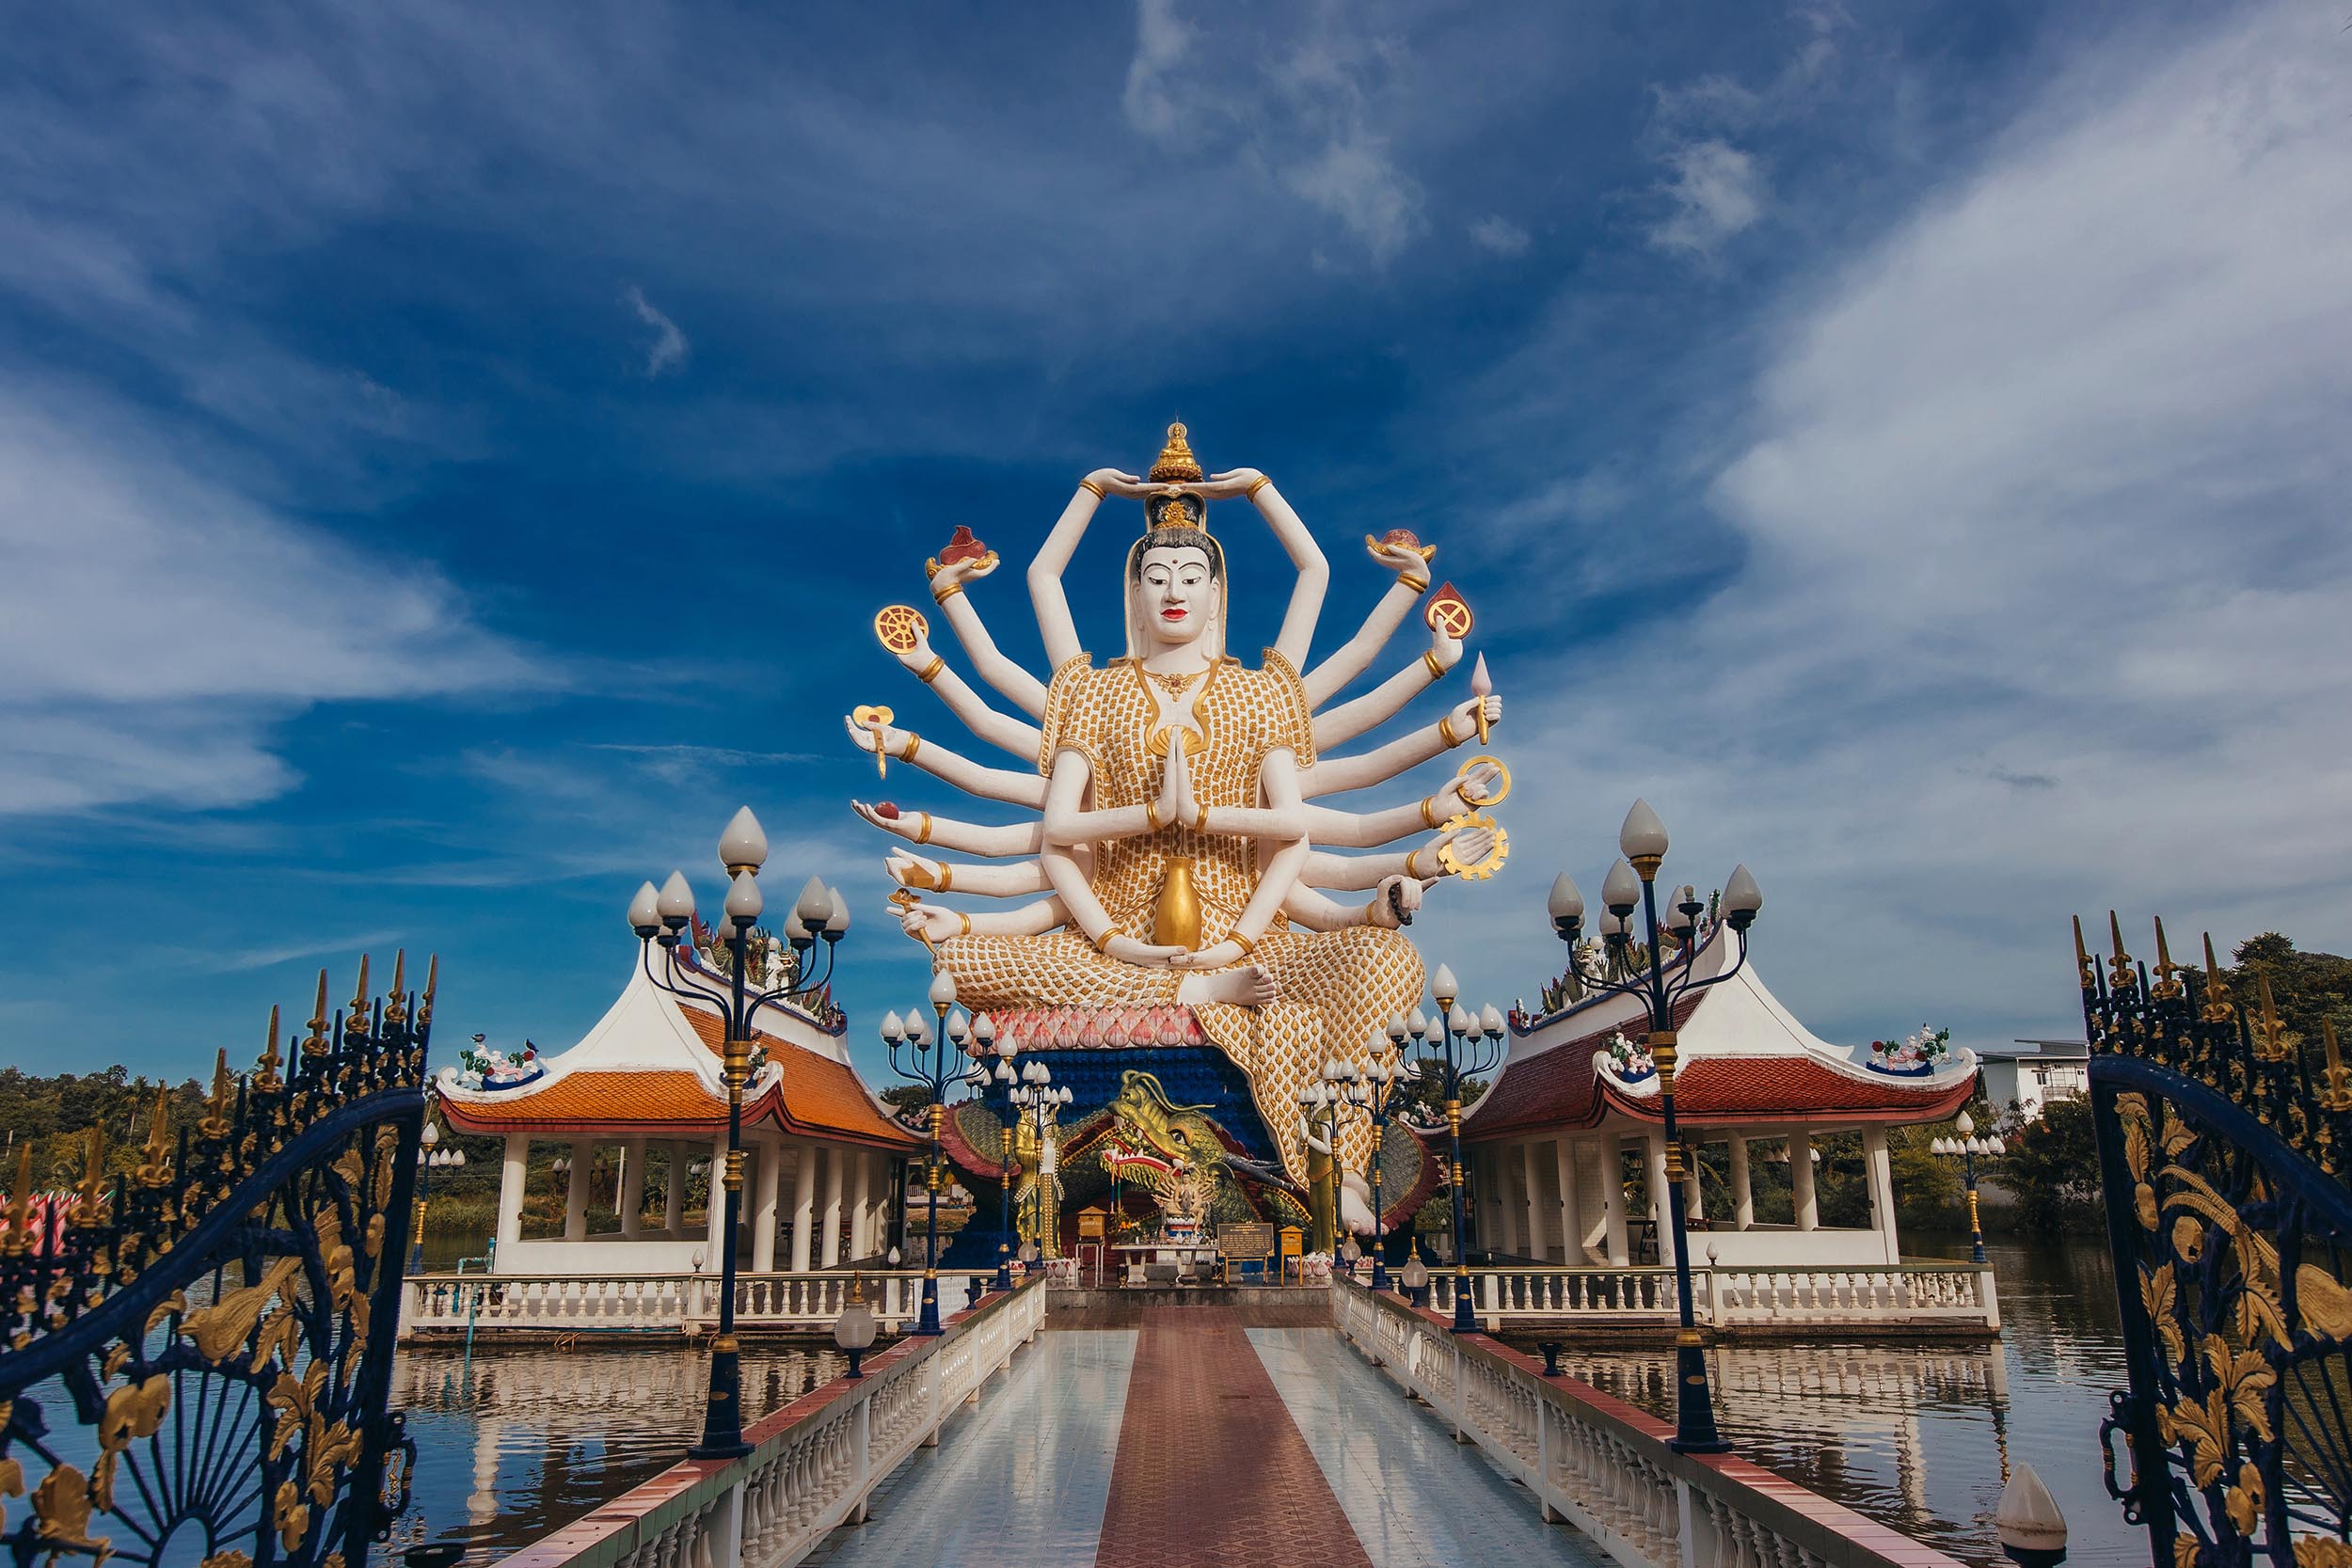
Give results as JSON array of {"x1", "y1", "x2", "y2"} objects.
[{"x1": 400, "y1": 1270, "x2": 995, "y2": 1338}]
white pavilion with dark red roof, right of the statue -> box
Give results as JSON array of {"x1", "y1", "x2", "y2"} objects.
[{"x1": 1463, "y1": 928, "x2": 1979, "y2": 1270}]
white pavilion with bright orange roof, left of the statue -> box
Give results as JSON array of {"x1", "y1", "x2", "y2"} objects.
[{"x1": 433, "y1": 947, "x2": 925, "y2": 1275}]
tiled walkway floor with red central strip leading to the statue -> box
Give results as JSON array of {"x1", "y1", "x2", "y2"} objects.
[{"x1": 809, "y1": 1307, "x2": 1604, "y2": 1568}]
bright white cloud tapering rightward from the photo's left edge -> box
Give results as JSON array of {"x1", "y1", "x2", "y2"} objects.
[{"x1": 0, "y1": 386, "x2": 546, "y2": 814}]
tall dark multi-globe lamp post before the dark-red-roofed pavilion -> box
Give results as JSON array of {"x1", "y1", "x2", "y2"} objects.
[{"x1": 1550, "y1": 800, "x2": 1764, "y2": 1453}]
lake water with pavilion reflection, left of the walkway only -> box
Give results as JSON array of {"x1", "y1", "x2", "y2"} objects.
[{"x1": 386, "y1": 1345, "x2": 847, "y2": 1561}]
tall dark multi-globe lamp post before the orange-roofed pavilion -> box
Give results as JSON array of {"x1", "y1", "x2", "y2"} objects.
[{"x1": 628, "y1": 806, "x2": 850, "y2": 1460}]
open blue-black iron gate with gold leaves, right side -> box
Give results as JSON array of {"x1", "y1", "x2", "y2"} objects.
[{"x1": 2074, "y1": 914, "x2": 2352, "y2": 1568}]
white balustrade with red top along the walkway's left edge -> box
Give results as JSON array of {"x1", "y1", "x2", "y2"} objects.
[{"x1": 503, "y1": 1276, "x2": 1044, "y2": 1568}]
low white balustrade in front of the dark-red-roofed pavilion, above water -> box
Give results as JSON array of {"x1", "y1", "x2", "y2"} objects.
[{"x1": 1391, "y1": 1262, "x2": 2002, "y2": 1328}]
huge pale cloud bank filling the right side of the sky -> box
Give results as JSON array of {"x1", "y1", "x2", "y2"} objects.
[{"x1": 1430, "y1": 5, "x2": 2352, "y2": 1053}]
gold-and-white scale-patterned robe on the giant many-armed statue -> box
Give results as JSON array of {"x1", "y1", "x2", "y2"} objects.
[{"x1": 939, "y1": 649, "x2": 1423, "y2": 1180}]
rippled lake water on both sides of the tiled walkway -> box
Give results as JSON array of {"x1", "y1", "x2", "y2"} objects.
[{"x1": 386, "y1": 1237, "x2": 2148, "y2": 1568}]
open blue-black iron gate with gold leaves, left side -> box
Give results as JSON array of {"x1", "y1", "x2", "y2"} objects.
[{"x1": 0, "y1": 959, "x2": 437, "y2": 1568}]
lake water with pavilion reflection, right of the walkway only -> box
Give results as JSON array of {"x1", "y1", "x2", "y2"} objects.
[{"x1": 1515, "y1": 1237, "x2": 2148, "y2": 1566}]
